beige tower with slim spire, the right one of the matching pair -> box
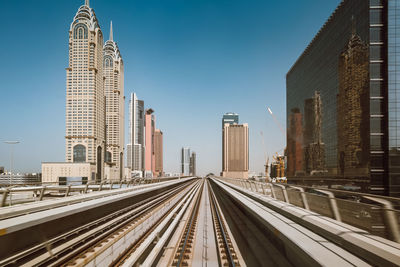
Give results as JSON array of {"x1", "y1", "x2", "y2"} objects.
[{"x1": 103, "y1": 22, "x2": 125, "y2": 179}]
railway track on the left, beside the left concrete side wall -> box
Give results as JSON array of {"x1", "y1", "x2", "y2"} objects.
[{"x1": 0, "y1": 179, "x2": 197, "y2": 266}]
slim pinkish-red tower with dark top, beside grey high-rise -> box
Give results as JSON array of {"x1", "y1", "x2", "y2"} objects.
[{"x1": 144, "y1": 108, "x2": 155, "y2": 177}]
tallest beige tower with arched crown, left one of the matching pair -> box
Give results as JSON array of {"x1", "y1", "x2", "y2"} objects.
[{"x1": 65, "y1": 0, "x2": 106, "y2": 180}]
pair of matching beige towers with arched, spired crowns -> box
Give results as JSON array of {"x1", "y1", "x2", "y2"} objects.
[{"x1": 65, "y1": 0, "x2": 125, "y2": 180}]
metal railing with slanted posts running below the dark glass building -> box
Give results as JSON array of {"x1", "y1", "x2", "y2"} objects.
[{"x1": 216, "y1": 177, "x2": 400, "y2": 243}]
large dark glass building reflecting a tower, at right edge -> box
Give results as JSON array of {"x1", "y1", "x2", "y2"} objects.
[{"x1": 286, "y1": 0, "x2": 400, "y2": 196}]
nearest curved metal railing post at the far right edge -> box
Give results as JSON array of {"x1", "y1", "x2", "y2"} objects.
[{"x1": 364, "y1": 196, "x2": 400, "y2": 243}]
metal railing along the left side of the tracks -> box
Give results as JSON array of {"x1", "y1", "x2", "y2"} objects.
[{"x1": 0, "y1": 177, "x2": 185, "y2": 207}]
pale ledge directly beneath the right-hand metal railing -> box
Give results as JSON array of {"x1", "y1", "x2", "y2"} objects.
[{"x1": 214, "y1": 179, "x2": 400, "y2": 266}]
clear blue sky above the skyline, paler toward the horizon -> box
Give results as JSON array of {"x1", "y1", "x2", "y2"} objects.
[{"x1": 0, "y1": 0, "x2": 340, "y2": 174}]
